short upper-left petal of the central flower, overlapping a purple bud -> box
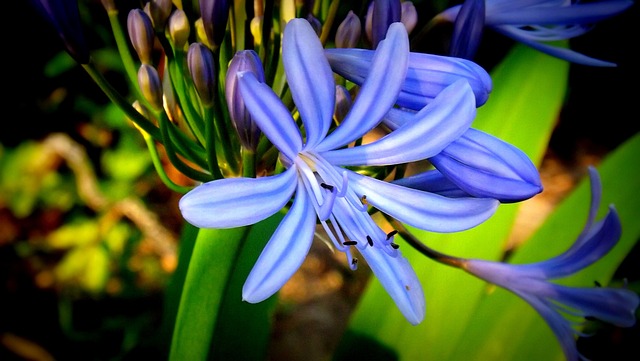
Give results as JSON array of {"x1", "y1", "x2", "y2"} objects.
[{"x1": 238, "y1": 72, "x2": 302, "y2": 159}]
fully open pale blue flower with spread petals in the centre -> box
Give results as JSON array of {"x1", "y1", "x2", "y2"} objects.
[{"x1": 180, "y1": 19, "x2": 498, "y2": 324}]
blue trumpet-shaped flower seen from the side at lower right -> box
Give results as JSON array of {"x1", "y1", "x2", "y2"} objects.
[{"x1": 463, "y1": 168, "x2": 640, "y2": 360}]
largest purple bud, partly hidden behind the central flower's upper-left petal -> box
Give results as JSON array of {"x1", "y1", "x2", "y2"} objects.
[{"x1": 225, "y1": 50, "x2": 265, "y2": 151}]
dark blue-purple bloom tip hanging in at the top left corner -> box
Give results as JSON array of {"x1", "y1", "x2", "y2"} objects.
[{"x1": 29, "y1": 0, "x2": 90, "y2": 64}]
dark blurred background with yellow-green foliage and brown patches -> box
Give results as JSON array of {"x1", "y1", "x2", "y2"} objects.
[{"x1": 0, "y1": 0, "x2": 640, "y2": 360}]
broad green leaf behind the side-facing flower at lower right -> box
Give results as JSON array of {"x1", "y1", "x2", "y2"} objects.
[{"x1": 452, "y1": 135, "x2": 640, "y2": 361}]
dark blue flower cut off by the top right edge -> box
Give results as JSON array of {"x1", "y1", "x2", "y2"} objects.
[{"x1": 435, "y1": 0, "x2": 633, "y2": 66}]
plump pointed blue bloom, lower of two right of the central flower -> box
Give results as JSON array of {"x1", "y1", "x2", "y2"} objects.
[{"x1": 429, "y1": 128, "x2": 542, "y2": 203}]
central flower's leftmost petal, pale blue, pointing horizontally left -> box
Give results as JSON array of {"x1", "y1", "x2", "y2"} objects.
[{"x1": 179, "y1": 169, "x2": 297, "y2": 228}]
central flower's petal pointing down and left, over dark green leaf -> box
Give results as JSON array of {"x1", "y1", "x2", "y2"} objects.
[{"x1": 242, "y1": 182, "x2": 316, "y2": 303}]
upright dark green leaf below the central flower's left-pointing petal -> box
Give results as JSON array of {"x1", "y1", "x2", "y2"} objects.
[{"x1": 169, "y1": 213, "x2": 282, "y2": 361}]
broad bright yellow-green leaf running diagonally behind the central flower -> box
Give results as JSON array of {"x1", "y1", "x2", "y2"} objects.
[{"x1": 338, "y1": 45, "x2": 568, "y2": 360}]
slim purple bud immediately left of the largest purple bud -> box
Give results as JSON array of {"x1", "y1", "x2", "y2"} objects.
[{"x1": 187, "y1": 43, "x2": 216, "y2": 105}]
